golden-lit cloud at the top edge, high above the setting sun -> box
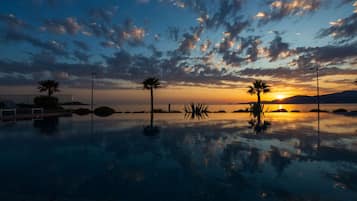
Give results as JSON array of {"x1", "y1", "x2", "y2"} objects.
[{"x1": 256, "y1": 0, "x2": 322, "y2": 24}]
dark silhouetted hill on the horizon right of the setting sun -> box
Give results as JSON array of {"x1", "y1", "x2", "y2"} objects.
[{"x1": 264, "y1": 91, "x2": 357, "y2": 104}]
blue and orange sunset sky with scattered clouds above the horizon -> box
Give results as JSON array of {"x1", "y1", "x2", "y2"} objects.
[{"x1": 0, "y1": 0, "x2": 357, "y2": 104}]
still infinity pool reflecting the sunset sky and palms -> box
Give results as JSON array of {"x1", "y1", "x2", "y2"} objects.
[{"x1": 0, "y1": 113, "x2": 357, "y2": 201}]
